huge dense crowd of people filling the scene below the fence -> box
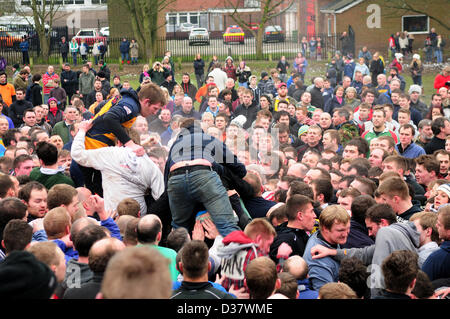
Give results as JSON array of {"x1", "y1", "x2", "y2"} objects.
[{"x1": 0, "y1": 31, "x2": 450, "y2": 299}]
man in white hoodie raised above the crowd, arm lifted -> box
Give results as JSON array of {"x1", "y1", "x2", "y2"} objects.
[{"x1": 71, "y1": 121, "x2": 164, "y2": 215}]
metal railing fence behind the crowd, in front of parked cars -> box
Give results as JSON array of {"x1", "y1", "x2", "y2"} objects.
[{"x1": 0, "y1": 28, "x2": 341, "y2": 64}]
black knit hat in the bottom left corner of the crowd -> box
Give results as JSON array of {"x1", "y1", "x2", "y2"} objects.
[{"x1": 0, "y1": 251, "x2": 57, "y2": 299}]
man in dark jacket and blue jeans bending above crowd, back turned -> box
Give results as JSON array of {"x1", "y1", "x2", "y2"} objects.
[{"x1": 164, "y1": 118, "x2": 247, "y2": 237}]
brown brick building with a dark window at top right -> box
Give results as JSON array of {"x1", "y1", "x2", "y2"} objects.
[{"x1": 317, "y1": 0, "x2": 450, "y2": 54}]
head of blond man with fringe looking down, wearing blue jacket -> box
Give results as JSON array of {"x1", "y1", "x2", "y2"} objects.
[{"x1": 319, "y1": 205, "x2": 350, "y2": 245}]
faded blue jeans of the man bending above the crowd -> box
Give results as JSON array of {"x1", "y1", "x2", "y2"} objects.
[{"x1": 167, "y1": 170, "x2": 240, "y2": 237}]
